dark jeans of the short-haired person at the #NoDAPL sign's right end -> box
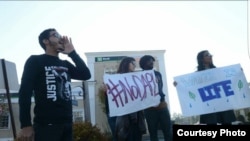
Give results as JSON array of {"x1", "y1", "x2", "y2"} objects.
[{"x1": 144, "y1": 107, "x2": 173, "y2": 141}]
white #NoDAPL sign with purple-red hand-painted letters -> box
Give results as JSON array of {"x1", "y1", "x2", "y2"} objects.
[{"x1": 103, "y1": 70, "x2": 160, "y2": 117}]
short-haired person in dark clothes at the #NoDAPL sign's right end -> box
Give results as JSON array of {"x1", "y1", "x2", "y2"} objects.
[{"x1": 139, "y1": 55, "x2": 173, "y2": 141}]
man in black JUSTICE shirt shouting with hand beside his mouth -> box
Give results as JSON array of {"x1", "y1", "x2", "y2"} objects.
[{"x1": 18, "y1": 28, "x2": 91, "y2": 141}]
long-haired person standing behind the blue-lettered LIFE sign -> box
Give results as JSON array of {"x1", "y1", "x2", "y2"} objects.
[{"x1": 197, "y1": 50, "x2": 236, "y2": 124}]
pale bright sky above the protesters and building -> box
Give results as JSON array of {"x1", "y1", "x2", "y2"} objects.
[{"x1": 0, "y1": 0, "x2": 250, "y2": 115}]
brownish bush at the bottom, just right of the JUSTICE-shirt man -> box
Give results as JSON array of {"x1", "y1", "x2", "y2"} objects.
[{"x1": 73, "y1": 122, "x2": 110, "y2": 141}]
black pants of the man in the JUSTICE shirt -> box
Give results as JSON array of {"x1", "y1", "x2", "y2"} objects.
[{"x1": 34, "y1": 123, "x2": 73, "y2": 141}]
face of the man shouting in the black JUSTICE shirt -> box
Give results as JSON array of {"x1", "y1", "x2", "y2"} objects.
[{"x1": 48, "y1": 31, "x2": 64, "y2": 52}]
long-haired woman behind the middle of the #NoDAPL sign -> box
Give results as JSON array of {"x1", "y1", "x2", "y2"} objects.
[{"x1": 115, "y1": 57, "x2": 146, "y2": 141}]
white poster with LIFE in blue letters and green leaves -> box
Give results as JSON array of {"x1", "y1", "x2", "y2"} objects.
[{"x1": 174, "y1": 64, "x2": 250, "y2": 116}]
